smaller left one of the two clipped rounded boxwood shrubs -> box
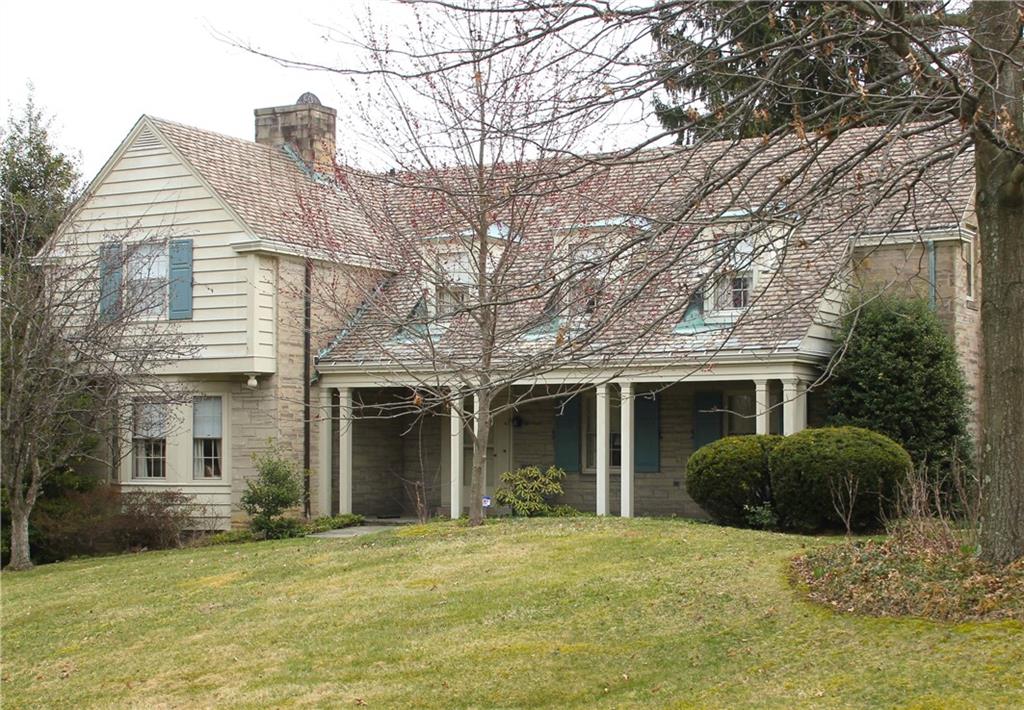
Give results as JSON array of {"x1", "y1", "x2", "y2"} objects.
[{"x1": 686, "y1": 435, "x2": 783, "y2": 527}]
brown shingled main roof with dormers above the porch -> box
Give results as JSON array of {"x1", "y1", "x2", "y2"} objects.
[{"x1": 321, "y1": 120, "x2": 973, "y2": 368}]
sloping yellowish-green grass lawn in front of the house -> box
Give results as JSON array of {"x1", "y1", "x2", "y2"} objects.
[{"x1": 2, "y1": 518, "x2": 1024, "y2": 708}]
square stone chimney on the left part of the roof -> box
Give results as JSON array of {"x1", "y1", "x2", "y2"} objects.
[{"x1": 253, "y1": 91, "x2": 338, "y2": 173}]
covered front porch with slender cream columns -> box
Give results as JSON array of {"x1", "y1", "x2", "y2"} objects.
[{"x1": 318, "y1": 362, "x2": 823, "y2": 517}]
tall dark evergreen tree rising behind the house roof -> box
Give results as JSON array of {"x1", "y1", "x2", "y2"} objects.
[{"x1": 653, "y1": 0, "x2": 943, "y2": 142}]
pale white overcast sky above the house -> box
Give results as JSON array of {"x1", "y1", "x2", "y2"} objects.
[{"x1": 0, "y1": 0, "x2": 659, "y2": 179}]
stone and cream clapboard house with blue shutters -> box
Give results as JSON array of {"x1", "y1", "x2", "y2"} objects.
[{"x1": 51, "y1": 94, "x2": 980, "y2": 527}]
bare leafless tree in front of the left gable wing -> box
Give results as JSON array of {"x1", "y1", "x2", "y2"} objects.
[{"x1": 0, "y1": 191, "x2": 193, "y2": 570}]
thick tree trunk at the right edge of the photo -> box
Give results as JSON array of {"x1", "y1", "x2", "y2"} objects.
[{"x1": 972, "y1": 2, "x2": 1024, "y2": 565}]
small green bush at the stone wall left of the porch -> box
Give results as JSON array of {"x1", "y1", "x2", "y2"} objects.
[{"x1": 242, "y1": 447, "x2": 302, "y2": 539}]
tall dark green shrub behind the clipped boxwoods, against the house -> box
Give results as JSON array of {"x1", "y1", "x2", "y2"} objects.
[{"x1": 827, "y1": 296, "x2": 971, "y2": 471}]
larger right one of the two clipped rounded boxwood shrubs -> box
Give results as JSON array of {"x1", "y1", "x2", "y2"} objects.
[{"x1": 768, "y1": 426, "x2": 911, "y2": 531}]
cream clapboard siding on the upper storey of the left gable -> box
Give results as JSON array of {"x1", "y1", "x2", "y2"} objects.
[{"x1": 60, "y1": 120, "x2": 275, "y2": 374}]
